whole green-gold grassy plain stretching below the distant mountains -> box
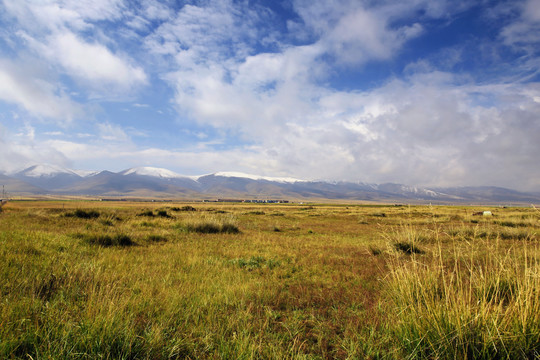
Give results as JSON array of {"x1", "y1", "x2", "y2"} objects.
[{"x1": 0, "y1": 201, "x2": 540, "y2": 360}]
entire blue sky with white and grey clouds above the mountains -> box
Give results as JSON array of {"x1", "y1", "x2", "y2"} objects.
[{"x1": 0, "y1": 0, "x2": 540, "y2": 191}]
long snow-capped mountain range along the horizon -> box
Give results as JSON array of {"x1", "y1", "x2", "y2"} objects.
[{"x1": 0, "y1": 165, "x2": 540, "y2": 204}]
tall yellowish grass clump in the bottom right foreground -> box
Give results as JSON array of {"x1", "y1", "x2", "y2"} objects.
[{"x1": 387, "y1": 226, "x2": 540, "y2": 359}]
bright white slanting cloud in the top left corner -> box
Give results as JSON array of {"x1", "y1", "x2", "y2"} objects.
[{"x1": 4, "y1": 0, "x2": 147, "y2": 98}]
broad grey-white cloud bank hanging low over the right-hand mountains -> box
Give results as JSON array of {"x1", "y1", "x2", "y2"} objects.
[{"x1": 169, "y1": 67, "x2": 540, "y2": 189}]
